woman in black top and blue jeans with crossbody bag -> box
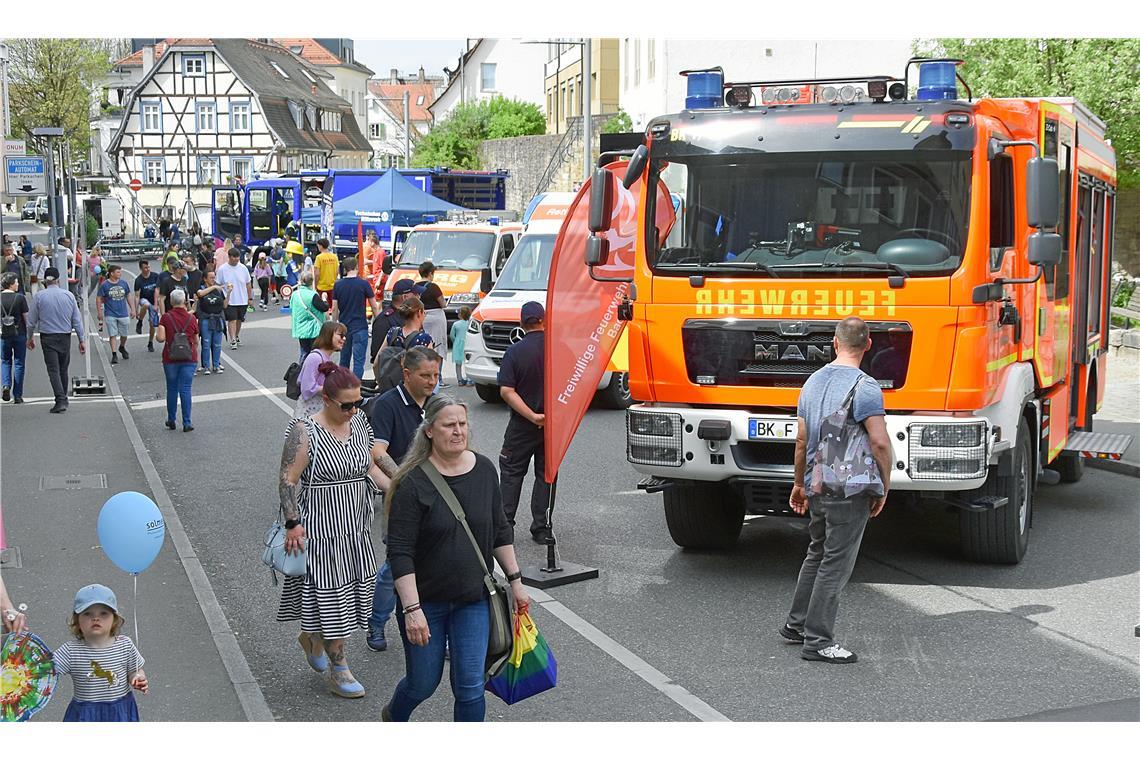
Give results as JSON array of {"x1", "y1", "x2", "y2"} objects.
[{"x1": 381, "y1": 394, "x2": 529, "y2": 721}]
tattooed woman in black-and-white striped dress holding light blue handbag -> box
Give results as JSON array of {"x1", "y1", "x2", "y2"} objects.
[{"x1": 277, "y1": 361, "x2": 389, "y2": 698}]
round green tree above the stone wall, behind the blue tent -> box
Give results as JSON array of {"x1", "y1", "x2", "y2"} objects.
[{"x1": 412, "y1": 96, "x2": 546, "y2": 169}]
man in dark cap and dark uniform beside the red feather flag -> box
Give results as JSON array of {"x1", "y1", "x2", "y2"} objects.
[{"x1": 498, "y1": 301, "x2": 552, "y2": 544}]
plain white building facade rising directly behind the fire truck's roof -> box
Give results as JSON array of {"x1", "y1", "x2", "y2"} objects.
[{"x1": 620, "y1": 38, "x2": 913, "y2": 131}]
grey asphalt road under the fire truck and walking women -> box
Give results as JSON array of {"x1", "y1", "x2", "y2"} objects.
[{"x1": 6, "y1": 215, "x2": 1140, "y2": 721}]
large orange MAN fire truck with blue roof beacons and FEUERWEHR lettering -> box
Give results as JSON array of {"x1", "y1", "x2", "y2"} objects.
[{"x1": 579, "y1": 58, "x2": 1129, "y2": 563}]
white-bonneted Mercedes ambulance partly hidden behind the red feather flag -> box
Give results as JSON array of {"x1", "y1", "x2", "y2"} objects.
[{"x1": 463, "y1": 193, "x2": 632, "y2": 409}]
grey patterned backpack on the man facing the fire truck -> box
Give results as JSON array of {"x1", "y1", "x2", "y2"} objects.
[{"x1": 811, "y1": 376, "x2": 884, "y2": 499}]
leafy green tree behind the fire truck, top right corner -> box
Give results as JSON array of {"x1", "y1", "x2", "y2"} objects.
[{"x1": 915, "y1": 39, "x2": 1140, "y2": 187}]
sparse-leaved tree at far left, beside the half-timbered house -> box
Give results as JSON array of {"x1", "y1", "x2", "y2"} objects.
[{"x1": 6, "y1": 39, "x2": 114, "y2": 157}]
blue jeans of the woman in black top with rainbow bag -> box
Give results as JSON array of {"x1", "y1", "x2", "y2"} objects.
[{"x1": 388, "y1": 599, "x2": 490, "y2": 722}]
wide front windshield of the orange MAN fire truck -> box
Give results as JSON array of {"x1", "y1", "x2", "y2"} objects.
[{"x1": 649, "y1": 150, "x2": 970, "y2": 278}]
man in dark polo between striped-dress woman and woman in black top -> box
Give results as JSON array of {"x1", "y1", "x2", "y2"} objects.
[{"x1": 367, "y1": 346, "x2": 443, "y2": 652}]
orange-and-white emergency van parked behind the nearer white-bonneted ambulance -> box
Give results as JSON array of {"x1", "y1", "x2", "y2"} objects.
[{"x1": 384, "y1": 216, "x2": 522, "y2": 325}]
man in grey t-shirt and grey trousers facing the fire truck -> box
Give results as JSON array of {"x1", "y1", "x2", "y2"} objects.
[{"x1": 780, "y1": 317, "x2": 891, "y2": 663}]
